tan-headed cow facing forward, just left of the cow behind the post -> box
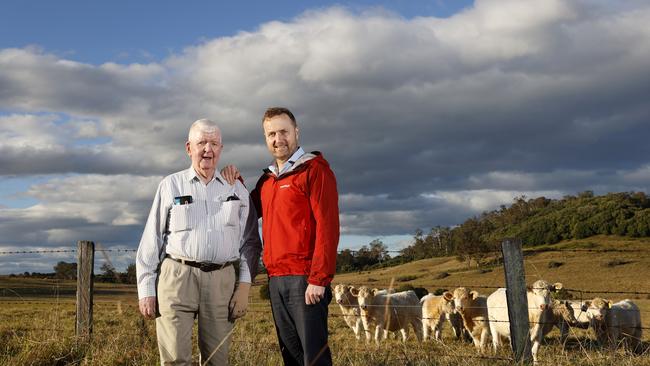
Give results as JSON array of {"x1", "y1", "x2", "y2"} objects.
[{"x1": 454, "y1": 287, "x2": 490, "y2": 350}]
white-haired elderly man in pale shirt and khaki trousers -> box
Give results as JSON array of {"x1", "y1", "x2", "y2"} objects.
[{"x1": 136, "y1": 119, "x2": 261, "y2": 365}]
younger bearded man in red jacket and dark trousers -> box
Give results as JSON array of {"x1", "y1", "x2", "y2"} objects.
[{"x1": 252, "y1": 108, "x2": 339, "y2": 365}]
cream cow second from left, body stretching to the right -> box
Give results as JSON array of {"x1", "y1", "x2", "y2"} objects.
[{"x1": 353, "y1": 286, "x2": 422, "y2": 344}]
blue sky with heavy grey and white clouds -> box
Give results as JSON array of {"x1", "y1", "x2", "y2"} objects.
[{"x1": 0, "y1": 0, "x2": 650, "y2": 274}]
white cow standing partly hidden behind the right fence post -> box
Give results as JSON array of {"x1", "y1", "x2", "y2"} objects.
[{"x1": 487, "y1": 280, "x2": 562, "y2": 362}]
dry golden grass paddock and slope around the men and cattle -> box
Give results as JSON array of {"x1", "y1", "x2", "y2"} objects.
[{"x1": 0, "y1": 237, "x2": 650, "y2": 366}]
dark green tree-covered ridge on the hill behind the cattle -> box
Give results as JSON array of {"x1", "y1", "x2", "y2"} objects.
[{"x1": 337, "y1": 191, "x2": 650, "y2": 272}]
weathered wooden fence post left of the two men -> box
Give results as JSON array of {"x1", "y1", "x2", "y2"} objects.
[{"x1": 75, "y1": 240, "x2": 95, "y2": 341}]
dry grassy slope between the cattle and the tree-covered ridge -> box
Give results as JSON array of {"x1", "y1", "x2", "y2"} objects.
[{"x1": 334, "y1": 235, "x2": 650, "y2": 298}]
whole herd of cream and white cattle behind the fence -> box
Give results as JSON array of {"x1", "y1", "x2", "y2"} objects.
[{"x1": 334, "y1": 280, "x2": 642, "y2": 361}]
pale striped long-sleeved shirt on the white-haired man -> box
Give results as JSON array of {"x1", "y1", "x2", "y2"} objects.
[{"x1": 136, "y1": 167, "x2": 251, "y2": 298}]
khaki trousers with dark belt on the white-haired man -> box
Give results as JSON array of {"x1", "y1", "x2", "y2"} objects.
[{"x1": 156, "y1": 258, "x2": 235, "y2": 366}]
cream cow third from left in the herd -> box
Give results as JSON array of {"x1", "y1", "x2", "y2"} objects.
[{"x1": 420, "y1": 291, "x2": 464, "y2": 341}]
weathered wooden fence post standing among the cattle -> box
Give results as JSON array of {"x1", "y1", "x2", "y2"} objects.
[{"x1": 501, "y1": 239, "x2": 532, "y2": 363}]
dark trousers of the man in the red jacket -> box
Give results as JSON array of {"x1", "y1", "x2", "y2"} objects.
[{"x1": 269, "y1": 276, "x2": 332, "y2": 366}]
